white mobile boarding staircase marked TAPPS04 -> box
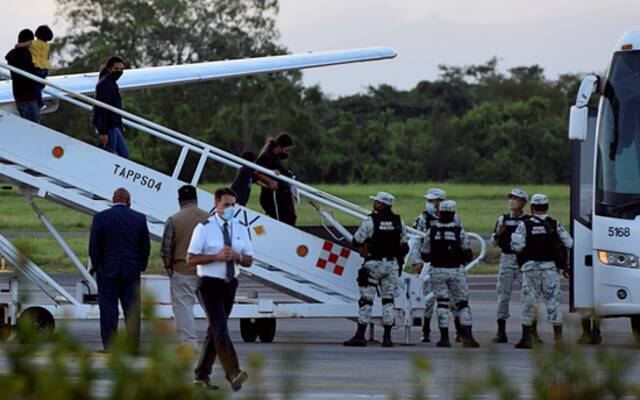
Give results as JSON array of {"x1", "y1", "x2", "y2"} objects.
[{"x1": 0, "y1": 64, "x2": 485, "y2": 342}]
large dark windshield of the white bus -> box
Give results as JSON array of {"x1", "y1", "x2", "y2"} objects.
[{"x1": 595, "y1": 51, "x2": 640, "y2": 219}]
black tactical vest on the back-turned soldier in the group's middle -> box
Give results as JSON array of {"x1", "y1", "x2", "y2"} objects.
[{"x1": 429, "y1": 225, "x2": 463, "y2": 268}]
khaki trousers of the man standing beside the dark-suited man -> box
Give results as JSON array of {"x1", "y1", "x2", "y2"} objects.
[{"x1": 171, "y1": 272, "x2": 198, "y2": 347}]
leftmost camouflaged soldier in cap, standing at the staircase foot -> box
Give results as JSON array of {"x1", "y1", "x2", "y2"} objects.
[{"x1": 343, "y1": 192, "x2": 408, "y2": 347}]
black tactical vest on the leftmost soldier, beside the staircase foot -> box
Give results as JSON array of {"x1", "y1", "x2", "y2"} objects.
[{"x1": 369, "y1": 212, "x2": 402, "y2": 260}]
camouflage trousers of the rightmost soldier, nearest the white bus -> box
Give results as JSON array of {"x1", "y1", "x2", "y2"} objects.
[{"x1": 522, "y1": 261, "x2": 562, "y2": 325}]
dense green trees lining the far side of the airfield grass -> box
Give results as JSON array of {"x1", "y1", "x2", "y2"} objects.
[{"x1": 43, "y1": 0, "x2": 580, "y2": 183}]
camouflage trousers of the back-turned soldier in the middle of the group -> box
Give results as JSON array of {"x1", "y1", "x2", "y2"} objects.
[{"x1": 431, "y1": 267, "x2": 473, "y2": 328}]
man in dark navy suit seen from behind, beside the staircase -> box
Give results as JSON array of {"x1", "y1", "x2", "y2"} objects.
[{"x1": 89, "y1": 188, "x2": 150, "y2": 352}]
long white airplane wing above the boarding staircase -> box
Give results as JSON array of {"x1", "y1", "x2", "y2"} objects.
[{"x1": 0, "y1": 47, "x2": 397, "y2": 105}]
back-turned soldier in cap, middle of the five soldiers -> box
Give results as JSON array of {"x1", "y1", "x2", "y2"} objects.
[{"x1": 424, "y1": 200, "x2": 479, "y2": 347}]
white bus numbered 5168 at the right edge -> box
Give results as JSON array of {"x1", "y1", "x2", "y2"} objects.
[{"x1": 569, "y1": 31, "x2": 640, "y2": 342}]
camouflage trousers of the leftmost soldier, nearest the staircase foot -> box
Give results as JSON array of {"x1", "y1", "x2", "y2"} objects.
[{"x1": 358, "y1": 260, "x2": 398, "y2": 326}]
